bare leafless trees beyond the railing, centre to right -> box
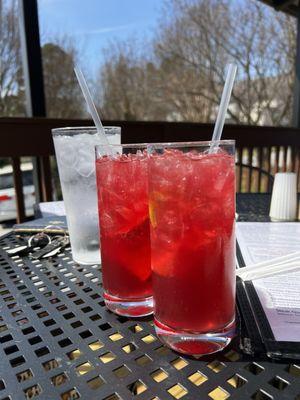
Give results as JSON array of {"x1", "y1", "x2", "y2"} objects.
[{"x1": 100, "y1": 0, "x2": 296, "y2": 125}]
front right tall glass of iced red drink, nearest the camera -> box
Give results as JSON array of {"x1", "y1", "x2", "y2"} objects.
[{"x1": 148, "y1": 141, "x2": 235, "y2": 356}]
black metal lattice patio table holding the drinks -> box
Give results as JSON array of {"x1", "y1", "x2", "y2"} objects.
[{"x1": 0, "y1": 194, "x2": 300, "y2": 400}]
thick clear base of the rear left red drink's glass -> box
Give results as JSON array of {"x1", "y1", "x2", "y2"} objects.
[{"x1": 103, "y1": 292, "x2": 153, "y2": 317}]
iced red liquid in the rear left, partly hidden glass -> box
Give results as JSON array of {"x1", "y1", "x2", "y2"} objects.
[{"x1": 96, "y1": 155, "x2": 152, "y2": 300}]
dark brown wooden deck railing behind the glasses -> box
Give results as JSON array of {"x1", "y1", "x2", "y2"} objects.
[{"x1": 0, "y1": 118, "x2": 300, "y2": 221}]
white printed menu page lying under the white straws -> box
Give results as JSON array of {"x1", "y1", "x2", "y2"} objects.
[{"x1": 236, "y1": 222, "x2": 300, "y2": 342}]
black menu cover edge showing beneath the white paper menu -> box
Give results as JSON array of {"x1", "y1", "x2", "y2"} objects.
[{"x1": 237, "y1": 244, "x2": 300, "y2": 359}]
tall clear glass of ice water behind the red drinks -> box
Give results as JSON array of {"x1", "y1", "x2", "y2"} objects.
[{"x1": 52, "y1": 126, "x2": 121, "y2": 265}]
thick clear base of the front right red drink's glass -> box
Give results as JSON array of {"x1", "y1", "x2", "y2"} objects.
[{"x1": 154, "y1": 318, "x2": 236, "y2": 357}]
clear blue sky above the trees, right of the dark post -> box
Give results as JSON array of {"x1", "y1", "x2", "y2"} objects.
[{"x1": 38, "y1": 0, "x2": 164, "y2": 75}]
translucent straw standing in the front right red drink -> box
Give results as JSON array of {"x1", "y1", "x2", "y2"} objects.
[{"x1": 210, "y1": 64, "x2": 237, "y2": 152}]
